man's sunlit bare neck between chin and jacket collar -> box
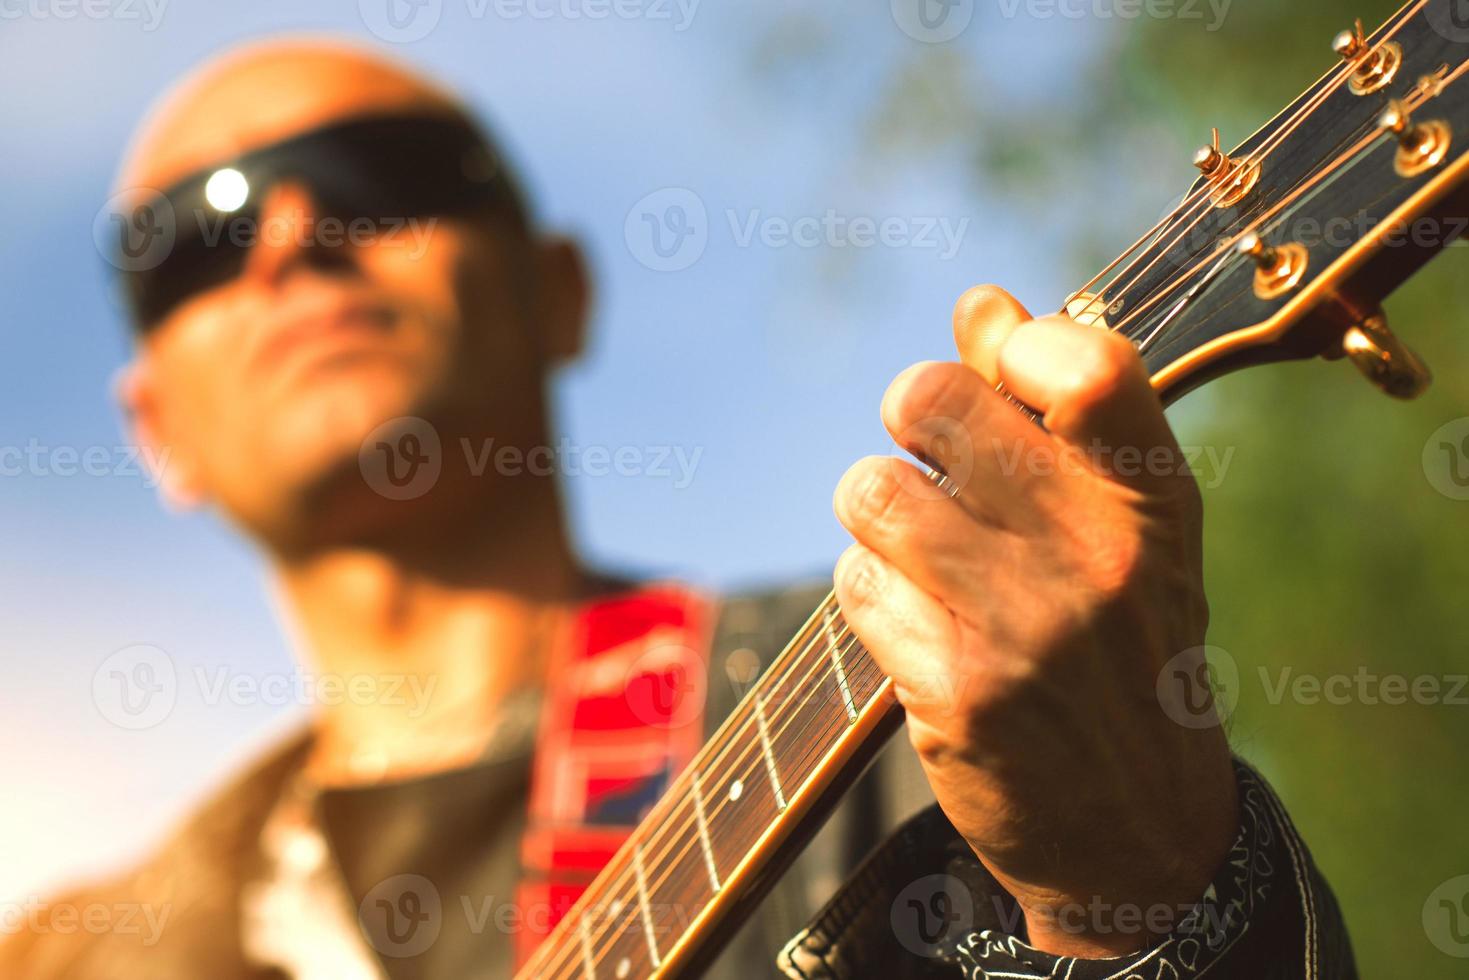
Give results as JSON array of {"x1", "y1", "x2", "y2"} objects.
[{"x1": 276, "y1": 488, "x2": 585, "y2": 783}]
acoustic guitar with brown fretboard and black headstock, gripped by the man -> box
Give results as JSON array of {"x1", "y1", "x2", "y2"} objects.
[{"x1": 517, "y1": 0, "x2": 1469, "y2": 980}]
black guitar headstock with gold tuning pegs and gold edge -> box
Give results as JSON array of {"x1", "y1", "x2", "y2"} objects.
[{"x1": 1066, "y1": 0, "x2": 1469, "y2": 398}]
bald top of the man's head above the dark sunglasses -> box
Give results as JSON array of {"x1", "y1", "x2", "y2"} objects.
[{"x1": 119, "y1": 38, "x2": 464, "y2": 188}]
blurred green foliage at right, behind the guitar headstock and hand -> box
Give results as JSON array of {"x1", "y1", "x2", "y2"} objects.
[{"x1": 1109, "y1": 0, "x2": 1469, "y2": 980}]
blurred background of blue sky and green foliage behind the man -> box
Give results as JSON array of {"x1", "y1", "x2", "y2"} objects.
[{"x1": 0, "y1": 0, "x2": 1469, "y2": 979}]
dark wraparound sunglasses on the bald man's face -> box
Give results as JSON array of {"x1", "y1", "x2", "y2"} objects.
[{"x1": 112, "y1": 115, "x2": 524, "y2": 334}]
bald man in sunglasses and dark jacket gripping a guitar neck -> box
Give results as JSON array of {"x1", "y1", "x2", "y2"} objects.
[{"x1": 0, "y1": 43, "x2": 1354, "y2": 980}]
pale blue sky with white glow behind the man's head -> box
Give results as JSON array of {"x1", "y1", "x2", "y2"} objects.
[{"x1": 0, "y1": 0, "x2": 1116, "y2": 901}]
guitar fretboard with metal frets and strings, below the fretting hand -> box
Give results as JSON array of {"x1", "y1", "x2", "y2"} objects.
[{"x1": 517, "y1": 595, "x2": 900, "y2": 980}]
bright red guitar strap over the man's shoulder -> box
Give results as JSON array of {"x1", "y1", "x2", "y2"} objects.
[{"x1": 516, "y1": 585, "x2": 715, "y2": 964}]
